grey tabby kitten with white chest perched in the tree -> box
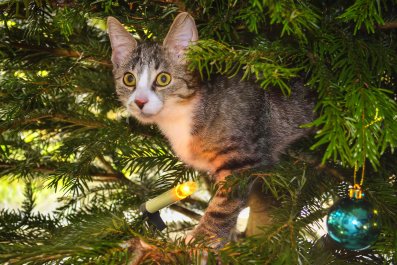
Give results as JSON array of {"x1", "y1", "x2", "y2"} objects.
[{"x1": 108, "y1": 13, "x2": 313, "y2": 247}]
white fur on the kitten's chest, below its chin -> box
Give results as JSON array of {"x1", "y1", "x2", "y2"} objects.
[{"x1": 156, "y1": 95, "x2": 211, "y2": 171}]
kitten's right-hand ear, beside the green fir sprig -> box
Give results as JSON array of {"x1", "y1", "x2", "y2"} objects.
[{"x1": 163, "y1": 12, "x2": 198, "y2": 58}]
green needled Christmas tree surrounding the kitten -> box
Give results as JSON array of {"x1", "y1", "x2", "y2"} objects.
[{"x1": 0, "y1": 0, "x2": 397, "y2": 264}]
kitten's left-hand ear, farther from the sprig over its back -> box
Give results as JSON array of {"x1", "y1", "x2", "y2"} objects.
[{"x1": 107, "y1": 17, "x2": 137, "y2": 67}]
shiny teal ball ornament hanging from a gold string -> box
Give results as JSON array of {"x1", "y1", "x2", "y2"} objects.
[{"x1": 327, "y1": 198, "x2": 380, "y2": 250}]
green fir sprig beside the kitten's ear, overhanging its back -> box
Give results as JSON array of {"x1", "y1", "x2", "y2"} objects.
[{"x1": 188, "y1": 40, "x2": 302, "y2": 94}]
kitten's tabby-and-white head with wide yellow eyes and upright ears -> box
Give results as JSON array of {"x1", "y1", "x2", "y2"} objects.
[{"x1": 107, "y1": 13, "x2": 198, "y2": 122}]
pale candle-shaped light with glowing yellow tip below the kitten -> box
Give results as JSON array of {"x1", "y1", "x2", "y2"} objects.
[{"x1": 145, "y1": 181, "x2": 197, "y2": 213}]
